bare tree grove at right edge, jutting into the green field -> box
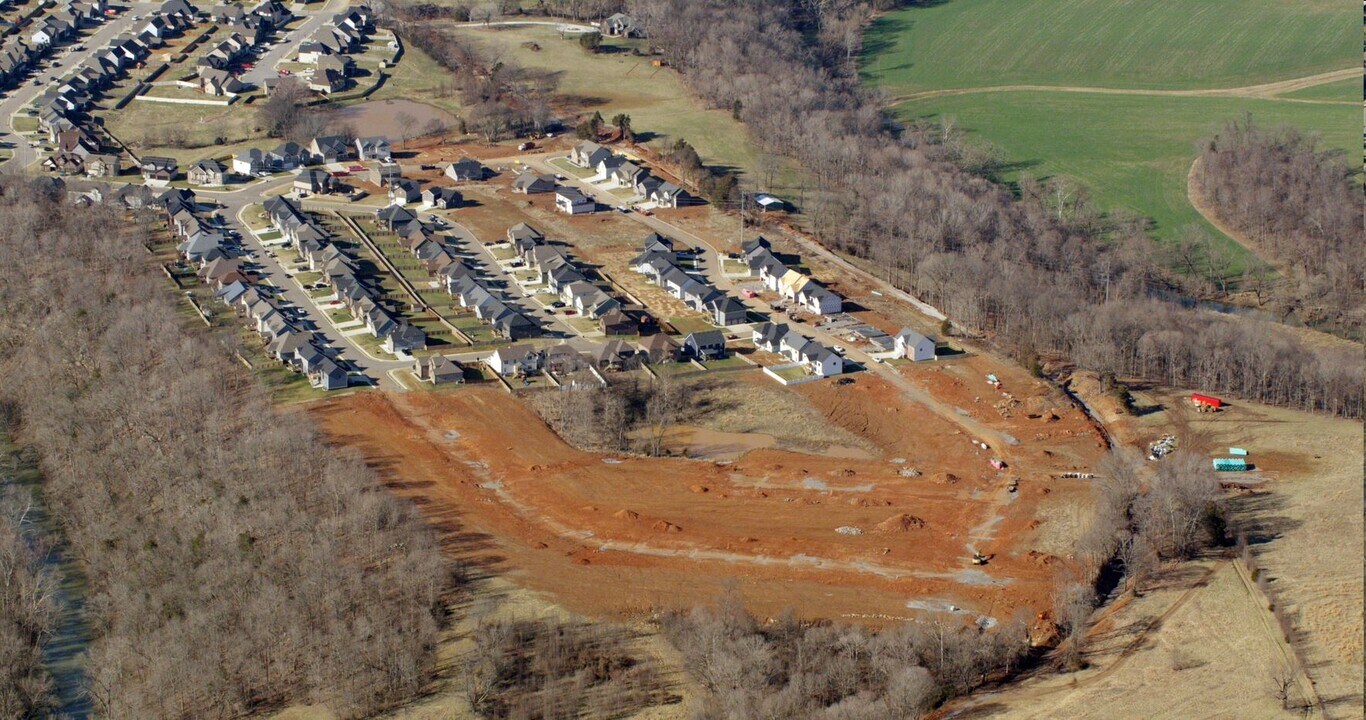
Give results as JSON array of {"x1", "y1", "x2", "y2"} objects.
[{"x1": 1197, "y1": 117, "x2": 1366, "y2": 339}]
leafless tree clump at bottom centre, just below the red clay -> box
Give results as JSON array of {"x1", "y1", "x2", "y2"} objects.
[{"x1": 663, "y1": 593, "x2": 1029, "y2": 720}]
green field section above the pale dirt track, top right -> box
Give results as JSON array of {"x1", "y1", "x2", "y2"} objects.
[{"x1": 862, "y1": 0, "x2": 1361, "y2": 92}]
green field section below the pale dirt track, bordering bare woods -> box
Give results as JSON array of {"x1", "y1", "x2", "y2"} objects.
[{"x1": 897, "y1": 92, "x2": 1361, "y2": 273}]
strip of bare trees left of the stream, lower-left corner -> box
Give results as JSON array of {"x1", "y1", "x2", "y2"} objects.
[{"x1": 0, "y1": 480, "x2": 57, "y2": 717}]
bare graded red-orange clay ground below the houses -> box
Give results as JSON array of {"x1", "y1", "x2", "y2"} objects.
[{"x1": 311, "y1": 376, "x2": 1098, "y2": 624}]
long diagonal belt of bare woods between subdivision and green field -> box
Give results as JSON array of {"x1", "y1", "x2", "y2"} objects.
[{"x1": 632, "y1": 0, "x2": 1363, "y2": 417}]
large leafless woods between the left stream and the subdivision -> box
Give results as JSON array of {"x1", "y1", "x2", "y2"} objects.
[{"x1": 0, "y1": 178, "x2": 449, "y2": 719}]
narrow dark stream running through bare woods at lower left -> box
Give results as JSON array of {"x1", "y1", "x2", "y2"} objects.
[{"x1": 0, "y1": 439, "x2": 92, "y2": 720}]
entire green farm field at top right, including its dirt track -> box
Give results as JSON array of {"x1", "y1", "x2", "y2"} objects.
[{"x1": 862, "y1": 0, "x2": 1361, "y2": 277}]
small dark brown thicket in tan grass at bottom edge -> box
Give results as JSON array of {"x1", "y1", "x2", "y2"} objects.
[{"x1": 459, "y1": 620, "x2": 668, "y2": 720}]
